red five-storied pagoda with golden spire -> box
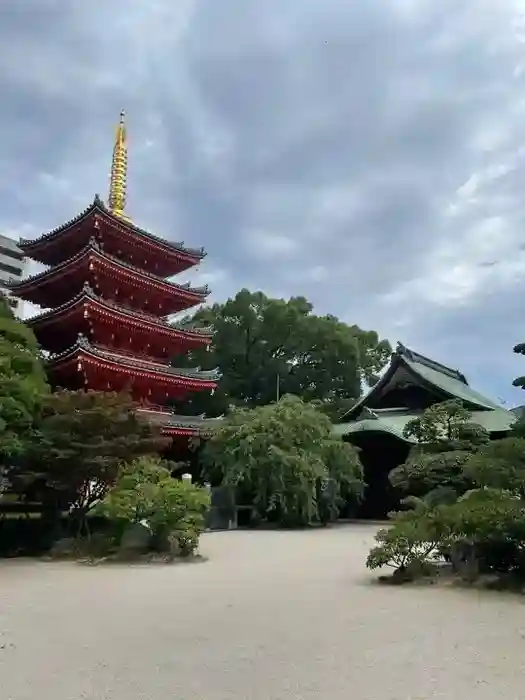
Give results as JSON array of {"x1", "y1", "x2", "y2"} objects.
[{"x1": 10, "y1": 113, "x2": 219, "y2": 437}]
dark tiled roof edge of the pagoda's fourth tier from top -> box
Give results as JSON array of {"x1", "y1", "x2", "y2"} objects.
[{"x1": 48, "y1": 334, "x2": 221, "y2": 384}]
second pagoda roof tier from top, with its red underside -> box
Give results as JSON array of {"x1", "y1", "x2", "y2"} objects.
[{"x1": 7, "y1": 239, "x2": 209, "y2": 316}]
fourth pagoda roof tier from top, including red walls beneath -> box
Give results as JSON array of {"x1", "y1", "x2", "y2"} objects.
[{"x1": 48, "y1": 336, "x2": 220, "y2": 403}]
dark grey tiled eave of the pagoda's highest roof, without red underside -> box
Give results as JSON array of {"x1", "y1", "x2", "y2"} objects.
[{"x1": 18, "y1": 195, "x2": 206, "y2": 264}]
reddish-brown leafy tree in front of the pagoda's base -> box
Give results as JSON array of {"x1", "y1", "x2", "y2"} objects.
[{"x1": 10, "y1": 391, "x2": 166, "y2": 523}]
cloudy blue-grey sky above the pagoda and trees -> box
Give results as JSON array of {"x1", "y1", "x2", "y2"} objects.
[{"x1": 0, "y1": 0, "x2": 525, "y2": 406}]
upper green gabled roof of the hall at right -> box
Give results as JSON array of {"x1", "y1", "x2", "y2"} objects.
[{"x1": 342, "y1": 343, "x2": 502, "y2": 422}]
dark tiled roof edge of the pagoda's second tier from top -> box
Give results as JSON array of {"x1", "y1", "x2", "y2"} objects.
[{"x1": 6, "y1": 244, "x2": 209, "y2": 304}]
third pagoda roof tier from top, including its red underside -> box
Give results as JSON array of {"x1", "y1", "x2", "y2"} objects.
[{"x1": 26, "y1": 283, "x2": 213, "y2": 358}]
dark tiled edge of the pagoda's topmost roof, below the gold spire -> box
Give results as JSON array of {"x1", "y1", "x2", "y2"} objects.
[{"x1": 18, "y1": 194, "x2": 206, "y2": 261}]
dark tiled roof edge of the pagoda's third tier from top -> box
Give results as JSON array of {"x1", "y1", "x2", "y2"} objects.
[{"x1": 25, "y1": 282, "x2": 213, "y2": 338}]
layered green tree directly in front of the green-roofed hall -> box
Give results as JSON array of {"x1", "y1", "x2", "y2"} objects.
[{"x1": 389, "y1": 401, "x2": 489, "y2": 502}]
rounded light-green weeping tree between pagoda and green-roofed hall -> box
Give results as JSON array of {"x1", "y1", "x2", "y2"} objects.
[{"x1": 203, "y1": 395, "x2": 363, "y2": 526}]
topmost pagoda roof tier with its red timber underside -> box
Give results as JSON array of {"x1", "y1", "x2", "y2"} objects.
[{"x1": 19, "y1": 195, "x2": 206, "y2": 277}]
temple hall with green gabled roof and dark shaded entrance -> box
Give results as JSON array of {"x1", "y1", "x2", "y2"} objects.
[{"x1": 335, "y1": 343, "x2": 516, "y2": 518}]
